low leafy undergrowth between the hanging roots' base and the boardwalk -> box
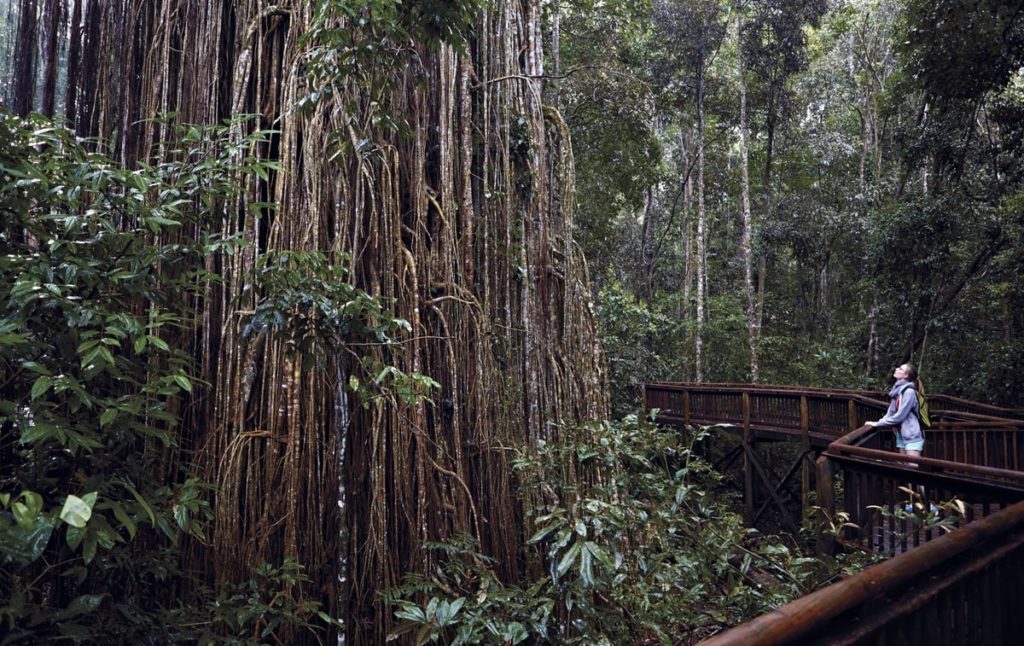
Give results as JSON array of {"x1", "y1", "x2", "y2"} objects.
[{"x1": 390, "y1": 417, "x2": 847, "y2": 644}]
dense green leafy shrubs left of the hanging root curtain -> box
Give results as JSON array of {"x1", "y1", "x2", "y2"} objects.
[{"x1": 0, "y1": 113, "x2": 344, "y2": 644}]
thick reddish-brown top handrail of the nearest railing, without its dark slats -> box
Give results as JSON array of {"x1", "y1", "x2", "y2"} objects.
[{"x1": 701, "y1": 502, "x2": 1024, "y2": 646}]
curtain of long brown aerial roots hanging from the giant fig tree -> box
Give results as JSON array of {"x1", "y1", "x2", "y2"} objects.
[{"x1": 9, "y1": 0, "x2": 605, "y2": 643}]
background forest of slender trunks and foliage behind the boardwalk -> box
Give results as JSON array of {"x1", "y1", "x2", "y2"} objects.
[{"x1": 565, "y1": 0, "x2": 1024, "y2": 413}]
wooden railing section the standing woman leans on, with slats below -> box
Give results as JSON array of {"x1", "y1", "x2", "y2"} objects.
[{"x1": 816, "y1": 420, "x2": 1024, "y2": 555}]
